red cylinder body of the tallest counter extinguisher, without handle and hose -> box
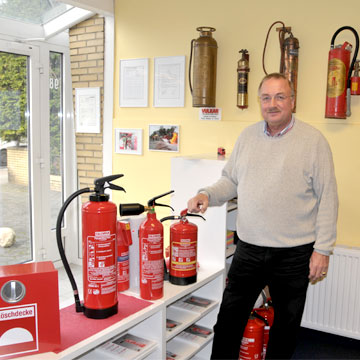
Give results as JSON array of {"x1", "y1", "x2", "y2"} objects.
[{"x1": 82, "y1": 196, "x2": 118, "y2": 319}]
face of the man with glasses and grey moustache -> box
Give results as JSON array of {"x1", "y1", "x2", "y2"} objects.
[{"x1": 259, "y1": 78, "x2": 294, "y2": 130}]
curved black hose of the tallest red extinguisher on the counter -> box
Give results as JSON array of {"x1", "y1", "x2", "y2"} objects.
[{"x1": 56, "y1": 188, "x2": 93, "y2": 312}]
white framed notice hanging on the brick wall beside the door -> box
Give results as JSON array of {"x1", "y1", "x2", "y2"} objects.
[{"x1": 75, "y1": 87, "x2": 100, "y2": 134}]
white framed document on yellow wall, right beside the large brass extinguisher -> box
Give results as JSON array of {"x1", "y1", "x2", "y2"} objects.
[{"x1": 154, "y1": 56, "x2": 185, "y2": 107}]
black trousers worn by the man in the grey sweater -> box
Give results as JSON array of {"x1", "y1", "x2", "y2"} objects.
[{"x1": 211, "y1": 240, "x2": 314, "y2": 359}]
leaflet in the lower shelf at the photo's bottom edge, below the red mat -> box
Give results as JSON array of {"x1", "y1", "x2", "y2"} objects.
[{"x1": 81, "y1": 333, "x2": 156, "y2": 360}]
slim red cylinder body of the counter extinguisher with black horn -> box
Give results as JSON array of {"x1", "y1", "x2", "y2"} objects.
[{"x1": 139, "y1": 209, "x2": 164, "y2": 300}]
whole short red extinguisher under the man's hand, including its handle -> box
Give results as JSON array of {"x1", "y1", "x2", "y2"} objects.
[{"x1": 160, "y1": 209, "x2": 205, "y2": 285}]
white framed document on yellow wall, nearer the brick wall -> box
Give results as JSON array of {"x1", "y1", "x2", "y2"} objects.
[{"x1": 119, "y1": 59, "x2": 149, "y2": 107}]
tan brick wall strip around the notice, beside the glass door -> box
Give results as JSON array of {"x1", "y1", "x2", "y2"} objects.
[{"x1": 69, "y1": 15, "x2": 105, "y2": 197}]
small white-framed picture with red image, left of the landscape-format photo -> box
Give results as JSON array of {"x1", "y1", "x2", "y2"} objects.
[{"x1": 115, "y1": 129, "x2": 142, "y2": 155}]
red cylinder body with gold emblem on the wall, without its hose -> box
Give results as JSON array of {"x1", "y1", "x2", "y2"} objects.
[{"x1": 325, "y1": 42, "x2": 351, "y2": 119}]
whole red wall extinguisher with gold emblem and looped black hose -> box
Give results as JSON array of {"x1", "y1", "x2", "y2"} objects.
[{"x1": 325, "y1": 26, "x2": 359, "y2": 119}]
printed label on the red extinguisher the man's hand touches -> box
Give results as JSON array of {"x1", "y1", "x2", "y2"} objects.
[{"x1": 171, "y1": 239, "x2": 197, "y2": 271}]
